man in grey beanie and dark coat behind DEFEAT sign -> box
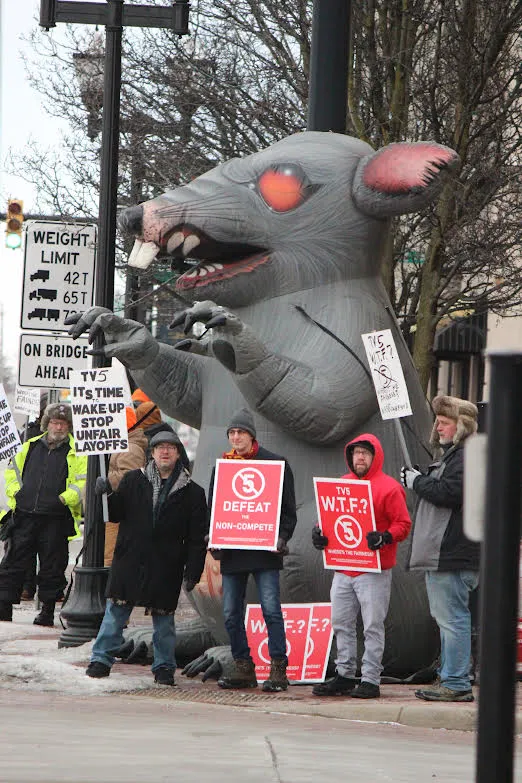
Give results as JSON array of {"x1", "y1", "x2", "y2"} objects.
[{"x1": 209, "y1": 408, "x2": 297, "y2": 692}]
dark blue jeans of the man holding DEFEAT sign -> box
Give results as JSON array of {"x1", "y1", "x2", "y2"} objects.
[{"x1": 222, "y1": 568, "x2": 286, "y2": 660}]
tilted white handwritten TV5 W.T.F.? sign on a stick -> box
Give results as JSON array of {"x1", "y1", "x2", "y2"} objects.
[{"x1": 361, "y1": 329, "x2": 412, "y2": 419}]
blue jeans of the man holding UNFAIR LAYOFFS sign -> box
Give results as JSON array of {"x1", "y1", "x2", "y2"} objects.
[{"x1": 91, "y1": 598, "x2": 176, "y2": 672}]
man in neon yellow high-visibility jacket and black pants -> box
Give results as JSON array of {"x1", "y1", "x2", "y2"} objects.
[{"x1": 0, "y1": 403, "x2": 87, "y2": 626}]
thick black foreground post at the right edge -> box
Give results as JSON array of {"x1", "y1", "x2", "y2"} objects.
[{"x1": 475, "y1": 351, "x2": 522, "y2": 783}]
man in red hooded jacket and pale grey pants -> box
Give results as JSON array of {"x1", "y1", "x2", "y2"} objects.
[{"x1": 312, "y1": 434, "x2": 411, "y2": 699}]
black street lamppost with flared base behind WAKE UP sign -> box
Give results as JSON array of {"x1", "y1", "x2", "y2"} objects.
[{"x1": 58, "y1": 0, "x2": 124, "y2": 647}]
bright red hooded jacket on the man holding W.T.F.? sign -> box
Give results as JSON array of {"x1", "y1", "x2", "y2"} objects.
[{"x1": 343, "y1": 434, "x2": 411, "y2": 576}]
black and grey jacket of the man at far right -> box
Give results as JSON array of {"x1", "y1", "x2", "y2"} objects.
[{"x1": 407, "y1": 442, "x2": 480, "y2": 571}]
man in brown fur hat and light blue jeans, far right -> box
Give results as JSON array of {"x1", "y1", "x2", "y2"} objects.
[{"x1": 401, "y1": 395, "x2": 480, "y2": 702}]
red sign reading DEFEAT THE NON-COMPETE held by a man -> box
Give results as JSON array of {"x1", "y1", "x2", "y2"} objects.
[{"x1": 209, "y1": 459, "x2": 285, "y2": 551}]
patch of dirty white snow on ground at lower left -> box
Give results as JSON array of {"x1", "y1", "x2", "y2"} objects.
[{"x1": 0, "y1": 605, "x2": 153, "y2": 696}]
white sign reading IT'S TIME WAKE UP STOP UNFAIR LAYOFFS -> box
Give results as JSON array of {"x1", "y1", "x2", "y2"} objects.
[{"x1": 71, "y1": 367, "x2": 129, "y2": 455}]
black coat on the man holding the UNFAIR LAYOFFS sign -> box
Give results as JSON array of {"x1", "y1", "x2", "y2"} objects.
[{"x1": 107, "y1": 470, "x2": 208, "y2": 612}]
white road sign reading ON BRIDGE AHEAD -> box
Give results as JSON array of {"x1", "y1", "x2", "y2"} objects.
[{"x1": 18, "y1": 332, "x2": 92, "y2": 389}]
